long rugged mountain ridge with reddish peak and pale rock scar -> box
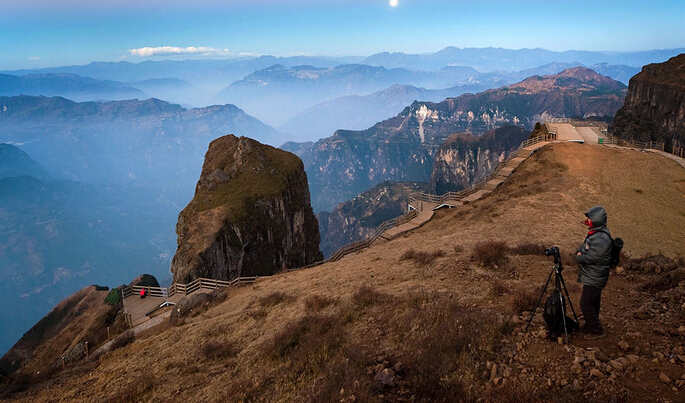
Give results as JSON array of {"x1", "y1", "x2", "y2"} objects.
[{"x1": 301, "y1": 67, "x2": 625, "y2": 211}]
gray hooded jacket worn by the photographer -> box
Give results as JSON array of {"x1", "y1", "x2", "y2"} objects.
[{"x1": 576, "y1": 206, "x2": 611, "y2": 289}]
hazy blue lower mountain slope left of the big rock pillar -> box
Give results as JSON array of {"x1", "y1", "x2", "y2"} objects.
[{"x1": 0, "y1": 144, "x2": 178, "y2": 352}]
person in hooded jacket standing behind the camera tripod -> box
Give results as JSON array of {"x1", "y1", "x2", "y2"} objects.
[{"x1": 576, "y1": 206, "x2": 612, "y2": 340}]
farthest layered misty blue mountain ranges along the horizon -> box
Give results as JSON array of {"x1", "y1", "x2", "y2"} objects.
[{"x1": 0, "y1": 47, "x2": 664, "y2": 134}]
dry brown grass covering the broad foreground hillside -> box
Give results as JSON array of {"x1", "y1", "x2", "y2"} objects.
[{"x1": 9, "y1": 144, "x2": 685, "y2": 403}]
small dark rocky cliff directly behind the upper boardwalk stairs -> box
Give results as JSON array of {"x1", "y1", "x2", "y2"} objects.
[{"x1": 430, "y1": 126, "x2": 528, "y2": 194}]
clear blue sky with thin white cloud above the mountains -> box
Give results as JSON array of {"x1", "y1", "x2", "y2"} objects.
[{"x1": 0, "y1": 0, "x2": 685, "y2": 69}]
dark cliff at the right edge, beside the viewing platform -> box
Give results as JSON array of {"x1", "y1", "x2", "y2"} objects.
[{"x1": 613, "y1": 54, "x2": 685, "y2": 145}]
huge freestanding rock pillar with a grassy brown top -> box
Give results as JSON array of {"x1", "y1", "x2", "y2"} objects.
[{"x1": 171, "y1": 135, "x2": 322, "y2": 283}]
